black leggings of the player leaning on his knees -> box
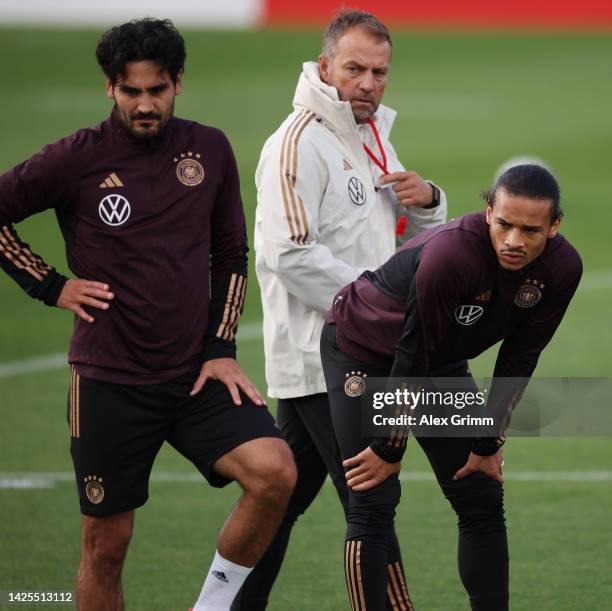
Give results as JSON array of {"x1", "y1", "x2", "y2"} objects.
[{"x1": 321, "y1": 324, "x2": 508, "y2": 611}]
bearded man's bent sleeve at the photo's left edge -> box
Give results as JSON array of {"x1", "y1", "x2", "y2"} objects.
[{"x1": 0, "y1": 132, "x2": 83, "y2": 305}]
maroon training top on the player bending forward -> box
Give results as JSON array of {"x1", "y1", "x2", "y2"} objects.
[{"x1": 327, "y1": 212, "x2": 582, "y2": 378}]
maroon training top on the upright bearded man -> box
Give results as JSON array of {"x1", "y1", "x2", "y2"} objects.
[{"x1": 0, "y1": 114, "x2": 247, "y2": 384}]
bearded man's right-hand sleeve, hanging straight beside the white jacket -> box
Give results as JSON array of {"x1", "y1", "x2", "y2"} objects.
[{"x1": 203, "y1": 135, "x2": 248, "y2": 361}]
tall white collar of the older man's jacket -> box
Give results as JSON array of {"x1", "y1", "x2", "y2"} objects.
[{"x1": 293, "y1": 62, "x2": 397, "y2": 138}]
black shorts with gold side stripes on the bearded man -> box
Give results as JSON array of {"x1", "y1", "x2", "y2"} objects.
[{"x1": 68, "y1": 370, "x2": 281, "y2": 516}]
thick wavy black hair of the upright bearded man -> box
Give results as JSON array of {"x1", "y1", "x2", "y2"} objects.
[{"x1": 96, "y1": 18, "x2": 186, "y2": 84}]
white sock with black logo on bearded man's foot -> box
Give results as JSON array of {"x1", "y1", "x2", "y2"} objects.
[{"x1": 193, "y1": 551, "x2": 253, "y2": 611}]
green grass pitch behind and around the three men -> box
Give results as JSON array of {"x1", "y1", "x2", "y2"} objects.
[{"x1": 0, "y1": 29, "x2": 612, "y2": 611}]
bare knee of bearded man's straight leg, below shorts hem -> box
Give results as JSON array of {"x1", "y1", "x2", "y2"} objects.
[{"x1": 83, "y1": 516, "x2": 132, "y2": 572}]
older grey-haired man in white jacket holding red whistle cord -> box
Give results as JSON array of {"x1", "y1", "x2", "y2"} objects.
[{"x1": 232, "y1": 11, "x2": 446, "y2": 611}]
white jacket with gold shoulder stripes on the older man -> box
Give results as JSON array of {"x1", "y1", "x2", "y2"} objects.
[{"x1": 254, "y1": 62, "x2": 447, "y2": 399}]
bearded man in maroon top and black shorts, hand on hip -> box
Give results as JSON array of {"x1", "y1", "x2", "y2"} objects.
[{"x1": 0, "y1": 19, "x2": 295, "y2": 611}]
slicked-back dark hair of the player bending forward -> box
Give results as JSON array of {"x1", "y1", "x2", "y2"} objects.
[{"x1": 482, "y1": 163, "x2": 563, "y2": 223}]
